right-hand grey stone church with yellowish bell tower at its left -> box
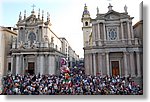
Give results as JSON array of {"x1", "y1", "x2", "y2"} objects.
[{"x1": 81, "y1": 4, "x2": 143, "y2": 77}]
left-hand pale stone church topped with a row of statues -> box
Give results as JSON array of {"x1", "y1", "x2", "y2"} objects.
[{"x1": 7, "y1": 8, "x2": 79, "y2": 75}]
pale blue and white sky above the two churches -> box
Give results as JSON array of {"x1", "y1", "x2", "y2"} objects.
[{"x1": 0, "y1": 0, "x2": 142, "y2": 58}]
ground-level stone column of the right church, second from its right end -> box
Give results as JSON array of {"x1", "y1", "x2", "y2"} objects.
[{"x1": 130, "y1": 52, "x2": 135, "y2": 77}]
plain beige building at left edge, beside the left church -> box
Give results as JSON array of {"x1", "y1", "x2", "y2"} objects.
[{"x1": 0, "y1": 27, "x2": 17, "y2": 76}]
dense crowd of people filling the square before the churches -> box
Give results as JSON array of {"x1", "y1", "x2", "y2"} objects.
[{"x1": 2, "y1": 68, "x2": 143, "y2": 95}]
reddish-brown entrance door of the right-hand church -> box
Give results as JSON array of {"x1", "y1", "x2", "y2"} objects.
[{"x1": 111, "y1": 61, "x2": 119, "y2": 76}]
